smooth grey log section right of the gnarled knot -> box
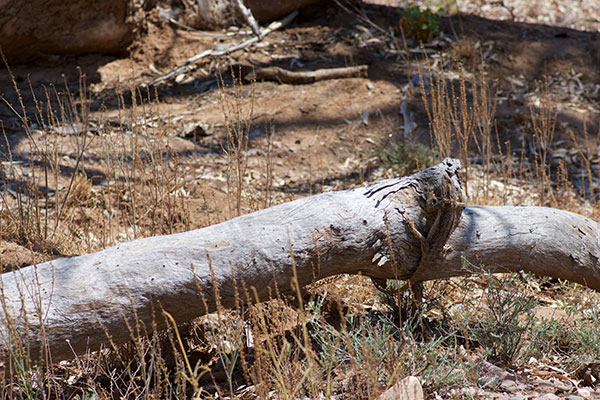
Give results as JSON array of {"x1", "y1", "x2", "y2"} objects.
[{"x1": 412, "y1": 206, "x2": 600, "y2": 290}]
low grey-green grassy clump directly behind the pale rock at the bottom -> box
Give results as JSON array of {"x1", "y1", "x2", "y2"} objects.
[{"x1": 307, "y1": 298, "x2": 466, "y2": 397}]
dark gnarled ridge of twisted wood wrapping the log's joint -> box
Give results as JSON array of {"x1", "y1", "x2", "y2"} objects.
[{"x1": 406, "y1": 158, "x2": 466, "y2": 284}]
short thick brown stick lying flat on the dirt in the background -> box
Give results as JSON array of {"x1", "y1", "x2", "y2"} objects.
[{"x1": 244, "y1": 65, "x2": 369, "y2": 84}]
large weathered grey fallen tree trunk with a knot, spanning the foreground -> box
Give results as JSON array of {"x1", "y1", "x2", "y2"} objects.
[{"x1": 0, "y1": 159, "x2": 600, "y2": 360}]
